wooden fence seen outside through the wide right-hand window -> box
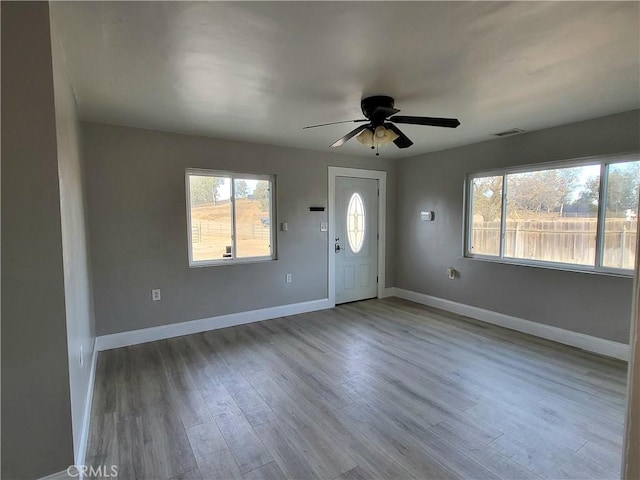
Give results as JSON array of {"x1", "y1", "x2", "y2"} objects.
[{"x1": 471, "y1": 218, "x2": 637, "y2": 269}]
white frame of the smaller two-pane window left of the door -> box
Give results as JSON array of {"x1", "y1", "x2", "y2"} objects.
[{"x1": 184, "y1": 168, "x2": 277, "y2": 268}]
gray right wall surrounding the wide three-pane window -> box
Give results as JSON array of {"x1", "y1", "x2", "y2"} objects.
[{"x1": 396, "y1": 111, "x2": 640, "y2": 343}]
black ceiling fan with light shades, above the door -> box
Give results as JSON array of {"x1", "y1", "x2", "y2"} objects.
[{"x1": 303, "y1": 95, "x2": 460, "y2": 155}]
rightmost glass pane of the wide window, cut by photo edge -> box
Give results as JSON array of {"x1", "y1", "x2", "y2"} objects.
[{"x1": 602, "y1": 162, "x2": 640, "y2": 269}]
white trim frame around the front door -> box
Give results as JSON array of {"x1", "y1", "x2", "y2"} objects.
[{"x1": 327, "y1": 167, "x2": 387, "y2": 308}]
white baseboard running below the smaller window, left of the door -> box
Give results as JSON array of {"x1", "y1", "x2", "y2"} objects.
[{"x1": 96, "y1": 298, "x2": 333, "y2": 351}]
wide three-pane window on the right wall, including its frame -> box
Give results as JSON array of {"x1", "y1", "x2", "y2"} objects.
[{"x1": 465, "y1": 157, "x2": 640, "y2": 273}]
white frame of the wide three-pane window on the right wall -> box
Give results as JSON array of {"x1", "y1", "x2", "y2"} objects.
[{"x1": 462, "y1": 152, "x2": 640, "y2": 277}]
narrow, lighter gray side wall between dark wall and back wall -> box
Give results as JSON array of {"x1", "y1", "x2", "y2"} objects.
[{"x1": 51, "y1": 10, "x2": 95, "y2": 458}]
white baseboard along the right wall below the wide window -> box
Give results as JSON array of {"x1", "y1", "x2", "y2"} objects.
[{"x1": 392, "y1": 287, "x2": 629, "y2": 361}]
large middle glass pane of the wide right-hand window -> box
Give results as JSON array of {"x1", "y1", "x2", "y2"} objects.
[{"x1": 504, "y1": 165, "x2": 600, "y2": 265}]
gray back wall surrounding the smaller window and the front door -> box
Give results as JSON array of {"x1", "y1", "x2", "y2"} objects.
[{"x1": 83, "y1": 123, "x2": 395, "y2": 335}]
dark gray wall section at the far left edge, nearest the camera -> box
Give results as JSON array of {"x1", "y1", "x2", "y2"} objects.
[{"x1": 0, "y1": 2, "x2": 73, "y2": 479}]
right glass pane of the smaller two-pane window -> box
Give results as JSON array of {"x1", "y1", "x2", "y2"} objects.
[{"x1": 234, "y1": 178, "x2": 271, "y2": 258}]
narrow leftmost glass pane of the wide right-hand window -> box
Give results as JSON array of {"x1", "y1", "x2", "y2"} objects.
[{"x1": 469, "y1": 176, "x2": 502, "y2": 256}]
